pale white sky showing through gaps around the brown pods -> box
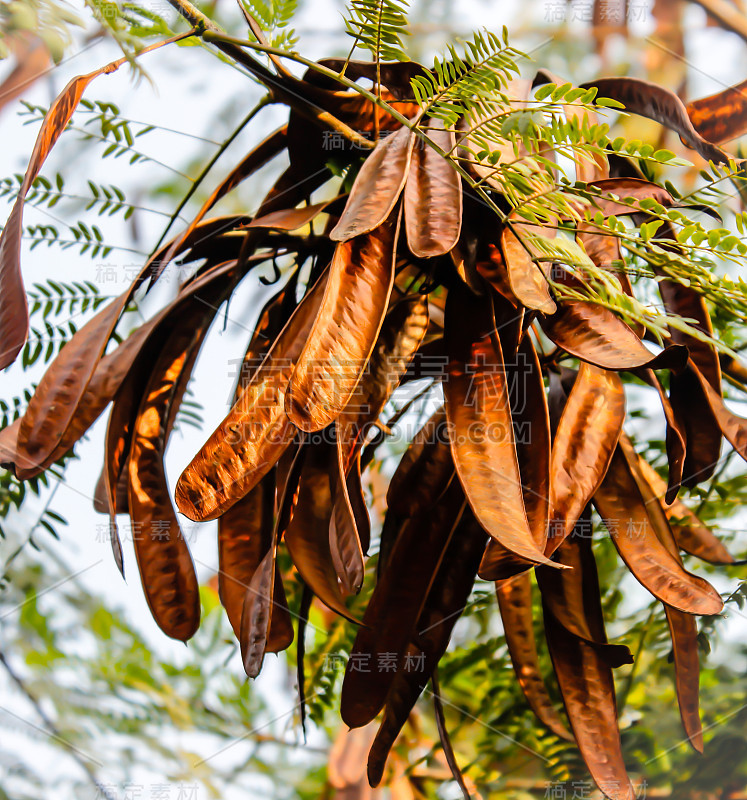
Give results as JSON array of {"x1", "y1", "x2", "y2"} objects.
[{"x1": 0, "y1": 0, "x2": 747, "y2": 800}]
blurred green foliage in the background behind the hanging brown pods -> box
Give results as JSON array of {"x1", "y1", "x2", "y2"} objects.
[{"x1": 0, "y1": 0, "x2": 747, "y2": 800}]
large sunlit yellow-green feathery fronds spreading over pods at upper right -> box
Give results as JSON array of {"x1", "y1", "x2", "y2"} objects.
[{"x1": 444, "y1": 72, "x2": 747, "y2": 344}]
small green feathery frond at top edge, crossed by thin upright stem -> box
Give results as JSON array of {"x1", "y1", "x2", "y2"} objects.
[{"x1": 345, "y1": 0, "x2": 409, "y2": 63}]
